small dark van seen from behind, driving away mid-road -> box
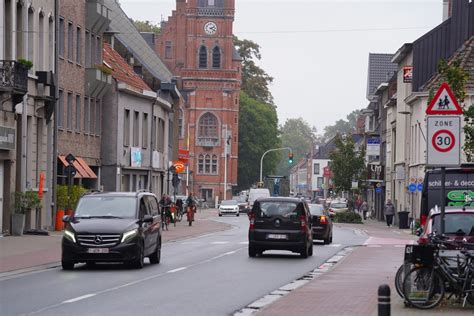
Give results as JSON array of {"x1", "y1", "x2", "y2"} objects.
[{"x1": 249, "y1": 197, "x2": 313, "y2": 258}]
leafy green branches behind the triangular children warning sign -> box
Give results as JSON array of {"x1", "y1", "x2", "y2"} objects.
[{"x1": 428, "y1": 60, "x2": 474, "y2": 162}]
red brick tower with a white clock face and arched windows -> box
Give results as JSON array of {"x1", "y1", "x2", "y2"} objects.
[{"x1": 155, "y1": 0, "x2": 241, "y2": 201}]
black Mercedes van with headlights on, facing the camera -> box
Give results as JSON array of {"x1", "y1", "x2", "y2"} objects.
[{"x1": 61, "y1": 192, "x2": 161, "y2": 270}]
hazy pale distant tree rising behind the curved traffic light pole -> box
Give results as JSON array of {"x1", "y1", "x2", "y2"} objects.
[{"x1": 277, "y1": 117, "x2": 319, "y2": 175}]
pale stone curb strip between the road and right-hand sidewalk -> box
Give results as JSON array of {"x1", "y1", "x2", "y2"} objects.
[{"x1": 232, "y1": 246, "x2": 358, "y2": 316}]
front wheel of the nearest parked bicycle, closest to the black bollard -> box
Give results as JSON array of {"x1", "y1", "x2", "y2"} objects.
[{"x1": 403, "y1": 267, "x2": 444, "y2": 309}]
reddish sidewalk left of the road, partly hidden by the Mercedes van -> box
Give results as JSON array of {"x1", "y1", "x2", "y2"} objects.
[{"x1": 0, "y1": 209, "x2": 231, "y2": 276}]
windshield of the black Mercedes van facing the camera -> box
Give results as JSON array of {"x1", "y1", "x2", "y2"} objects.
[{"x1": 74, "y1": 196, "x2": 136, "y2": 218}]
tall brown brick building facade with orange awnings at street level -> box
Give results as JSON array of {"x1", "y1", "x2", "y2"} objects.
[{"x1": 56, "y1": 0, "x2": 112, "y2": 189}]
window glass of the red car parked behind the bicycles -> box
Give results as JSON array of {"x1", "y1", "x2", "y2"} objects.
[{"x1": 432, "y1": 212, "x2": 474, "y2": 236}]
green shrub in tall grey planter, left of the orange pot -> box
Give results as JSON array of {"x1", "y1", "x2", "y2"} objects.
[{"x1": 11, "y1": 190, "x2": 41, "y2": 236}]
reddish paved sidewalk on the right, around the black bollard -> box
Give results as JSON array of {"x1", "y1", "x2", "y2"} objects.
[{"x1": 258, "y1": 220, "x2": 473, "y2": 316}]
